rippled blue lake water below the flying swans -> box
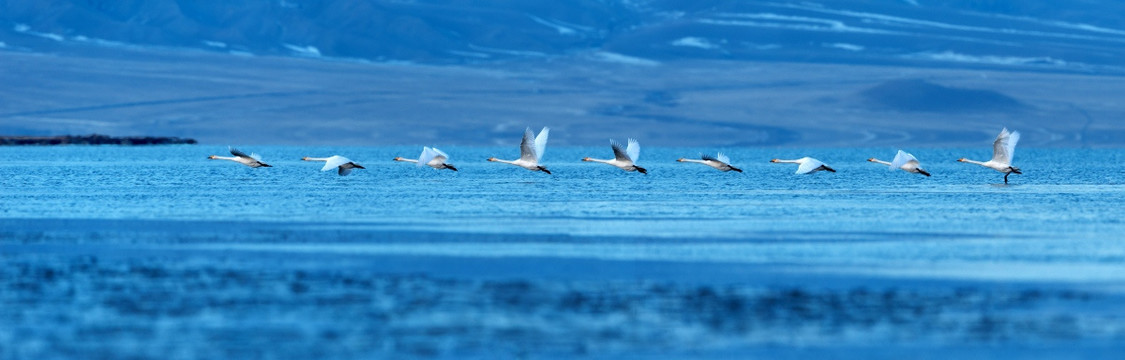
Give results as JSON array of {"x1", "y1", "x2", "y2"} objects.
[{"x1": 0, "y1": 146, "x2": 1125, "y2": 359}]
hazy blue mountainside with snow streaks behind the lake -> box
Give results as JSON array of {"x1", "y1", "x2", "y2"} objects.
[{"x1": 0, "y1": 0, "x2": 1125, "y2": 146}]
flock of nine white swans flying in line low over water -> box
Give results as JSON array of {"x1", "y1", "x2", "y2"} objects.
[{"x1": 208, "y1": 127, "x2": 1023, "y2": 183}]
